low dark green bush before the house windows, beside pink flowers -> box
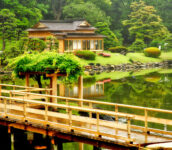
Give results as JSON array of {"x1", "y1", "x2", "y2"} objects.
[{"x1": 74, "y1": 50, "x2": 96, "y2": 60}]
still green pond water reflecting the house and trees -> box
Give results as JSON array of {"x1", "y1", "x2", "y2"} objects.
[{"x1": 0, "y1": 68, "x2": 172, "y2": 150}]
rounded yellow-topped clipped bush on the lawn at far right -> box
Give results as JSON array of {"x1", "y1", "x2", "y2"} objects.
[{"x1": 144, "y1": 47, "x2": 161, "y2": 58}]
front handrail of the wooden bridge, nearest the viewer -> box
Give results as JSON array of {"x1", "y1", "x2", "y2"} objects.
[{"x1": 0, "y1": 96, "x2": 133, "y2": 142}]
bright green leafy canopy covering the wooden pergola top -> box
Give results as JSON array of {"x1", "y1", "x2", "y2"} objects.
[{"x1": 8, "y1": 52, "x2": 83, "y2": 82}]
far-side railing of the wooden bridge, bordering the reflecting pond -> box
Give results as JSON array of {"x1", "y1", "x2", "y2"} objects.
[{"x1": 8, "y1": 91, "x2": 172, "y2": 140}]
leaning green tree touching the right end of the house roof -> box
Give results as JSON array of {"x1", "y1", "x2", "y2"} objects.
[{"x1": 95, "y1": 22, "x2": 119, "y2": 50}]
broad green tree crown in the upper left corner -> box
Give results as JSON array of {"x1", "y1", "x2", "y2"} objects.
[{"x1": 0, "y1": 0, "x2": 42, "y2": 29}]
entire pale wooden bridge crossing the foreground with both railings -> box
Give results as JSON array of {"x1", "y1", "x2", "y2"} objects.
[{"x1": 0, "y1": 84, "x2": 172, "y2": 148}]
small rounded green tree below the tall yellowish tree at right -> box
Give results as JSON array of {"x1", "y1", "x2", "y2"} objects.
[{"x1": 130, "y1": 39, "x2": 146, "y2": 52}]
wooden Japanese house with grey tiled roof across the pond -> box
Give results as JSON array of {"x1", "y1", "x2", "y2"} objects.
[{"x1": 27, "y1": 20, "x2": 104, "y2": 53}]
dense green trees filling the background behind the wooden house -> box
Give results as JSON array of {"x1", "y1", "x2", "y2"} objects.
[{"x1": 0, "y1": 0, "x2": 172, "y2": 63}]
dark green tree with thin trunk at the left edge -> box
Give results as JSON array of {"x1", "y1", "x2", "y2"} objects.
[{"x1": 0, "y1": 9, "x2": 16, "y2": 51}]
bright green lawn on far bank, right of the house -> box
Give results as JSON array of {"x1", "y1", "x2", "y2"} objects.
[{"x1": 80, "y1": 52, "x2": 172, "y2": 65}]
